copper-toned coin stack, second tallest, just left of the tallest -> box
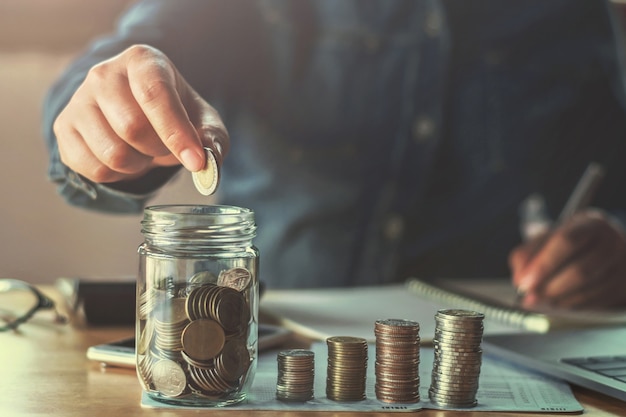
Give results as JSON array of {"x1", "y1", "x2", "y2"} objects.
[{"x1": 374, "y1": 319, "x2": 420, "y2": 403}]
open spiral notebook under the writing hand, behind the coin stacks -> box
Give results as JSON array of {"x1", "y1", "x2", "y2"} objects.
[{"x1": 261, "y1": 278, "x2": 626, "y2": 342}]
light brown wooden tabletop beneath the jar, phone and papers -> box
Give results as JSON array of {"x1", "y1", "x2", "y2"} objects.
[{"x1": 0, "y1": 286, "x2": 626, "y2": 417}]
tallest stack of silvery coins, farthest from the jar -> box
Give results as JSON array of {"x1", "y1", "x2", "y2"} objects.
[{"x1": 428, "y1": 310, "x2": 485, "y2": 408}]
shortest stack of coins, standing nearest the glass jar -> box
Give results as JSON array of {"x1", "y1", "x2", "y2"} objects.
[{"x1": 276, "y1": 349, "x2": 315, "y2": 402}]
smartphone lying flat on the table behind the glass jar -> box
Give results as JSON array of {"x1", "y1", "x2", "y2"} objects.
[{"x1": 87, "y1": 324, "x2": 291, "y2": 368}]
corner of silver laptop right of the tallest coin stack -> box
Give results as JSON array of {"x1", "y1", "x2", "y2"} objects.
[{"x1": 482, "y1": 327, "x2": 626, "y2": 401}]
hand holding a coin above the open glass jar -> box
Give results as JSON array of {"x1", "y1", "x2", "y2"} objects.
[{"x1": 54, "y1": 45, "x2": 230, "y2": 183}]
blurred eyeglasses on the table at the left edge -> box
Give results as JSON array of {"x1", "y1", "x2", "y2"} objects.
[{"x1": 0, "y1": 278, "x2": 67, "y2": 332}]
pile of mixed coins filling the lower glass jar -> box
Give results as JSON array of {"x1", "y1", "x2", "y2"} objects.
[{"x1": 137, "y1": 268, "x2": 253, "y2": 399}]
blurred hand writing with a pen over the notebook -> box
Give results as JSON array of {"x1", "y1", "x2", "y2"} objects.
[{"x1": 509, "y1": 210, "x2": 626, "y2": 309}]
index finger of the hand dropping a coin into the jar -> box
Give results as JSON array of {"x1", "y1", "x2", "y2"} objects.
[{"x1": 127, "y1": 47, "x2": 205, "y2": 172}]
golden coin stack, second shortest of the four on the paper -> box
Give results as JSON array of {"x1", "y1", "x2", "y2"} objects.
[{"x1": 326, "y1": 336, "x2": 367, "y2": 401}]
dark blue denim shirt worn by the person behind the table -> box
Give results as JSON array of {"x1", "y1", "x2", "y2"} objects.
[{"x1": 44, "y1": 0, "x2": 626, "y2": 287}]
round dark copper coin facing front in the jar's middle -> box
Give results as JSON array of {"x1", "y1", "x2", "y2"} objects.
[{"x1": 181, "y1": 319, "x2": 226, "y2": 361}]
